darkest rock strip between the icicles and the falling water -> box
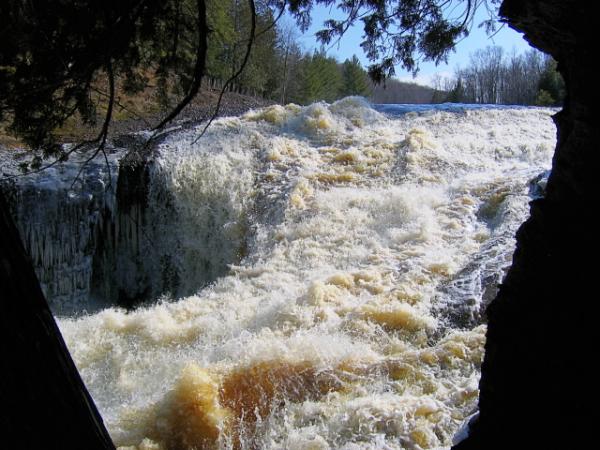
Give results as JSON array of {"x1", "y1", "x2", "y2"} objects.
[{"x1": 90, "y1": 151, "x2": 185, "y2": 307}]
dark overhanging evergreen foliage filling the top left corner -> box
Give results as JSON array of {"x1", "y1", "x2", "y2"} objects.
[{"x1": 0, "y1": 0, "x2": 208, "y2": 157}]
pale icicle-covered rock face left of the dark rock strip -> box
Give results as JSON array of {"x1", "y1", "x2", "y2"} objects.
[{"x1": 0, "y1": 154, "x2": 118, "y2": 313}]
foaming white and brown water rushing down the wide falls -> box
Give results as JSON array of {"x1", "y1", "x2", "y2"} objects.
[{"x1": 54, "y1": 98, "x2": 555, "y2": 450}]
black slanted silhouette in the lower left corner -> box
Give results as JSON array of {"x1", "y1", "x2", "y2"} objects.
[{"x1": 0, "y1": 191, "x2": 114, "y2": 450}]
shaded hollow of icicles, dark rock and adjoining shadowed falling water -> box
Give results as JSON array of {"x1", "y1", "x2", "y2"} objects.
[{"x1": 0, "y1": 136, "x2": 252, "y2": 316}]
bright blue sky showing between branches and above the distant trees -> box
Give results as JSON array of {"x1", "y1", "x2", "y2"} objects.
[{"x1": 287, "y1": 2, "x2": 531, "y2": 84}]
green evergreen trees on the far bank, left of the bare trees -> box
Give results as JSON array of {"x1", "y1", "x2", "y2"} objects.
[{"x1": 146, "y1": 0, "x2": 371, "y2": 105}]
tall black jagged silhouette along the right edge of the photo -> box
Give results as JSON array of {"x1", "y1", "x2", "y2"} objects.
[{"x1": 455, "y1": 0, "x2": 599, "y2": 450}]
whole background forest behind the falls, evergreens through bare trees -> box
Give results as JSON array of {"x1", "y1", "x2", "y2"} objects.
[{"x1": 119, "y1": 0, "x2": 564, "y2": 108}]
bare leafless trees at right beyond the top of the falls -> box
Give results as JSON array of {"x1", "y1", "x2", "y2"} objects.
[{"x1": 435, "y1": 46, "x2": 565, "y2": 106}]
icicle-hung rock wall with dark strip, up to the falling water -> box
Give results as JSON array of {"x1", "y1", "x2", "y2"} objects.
[{"x1": 0, "y1": 147, "x2": 180, "y2": 315}]
